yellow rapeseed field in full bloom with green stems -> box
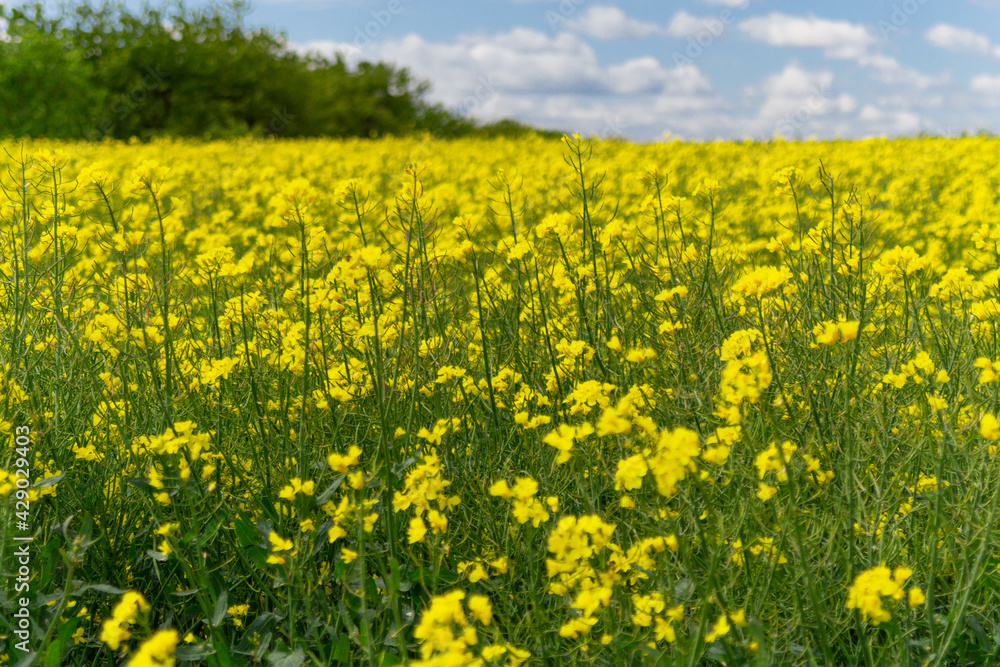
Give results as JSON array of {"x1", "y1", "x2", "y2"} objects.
[{"x1": 0, "y1": 136, "x2": 1000, "y2": 667}]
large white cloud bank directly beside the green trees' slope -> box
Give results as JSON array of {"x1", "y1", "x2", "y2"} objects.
[{"x1": 292, "y1": 28, "x2": 724, "y2": 138}]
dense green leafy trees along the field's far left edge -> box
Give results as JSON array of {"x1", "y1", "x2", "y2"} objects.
[{"x1": 0, "y1": 1, "x2": 532, "y2": 140}]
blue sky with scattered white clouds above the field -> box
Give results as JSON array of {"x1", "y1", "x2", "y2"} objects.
[{"x1": 164, "y1": 0, "x2": 1000, "y2": 141}]
